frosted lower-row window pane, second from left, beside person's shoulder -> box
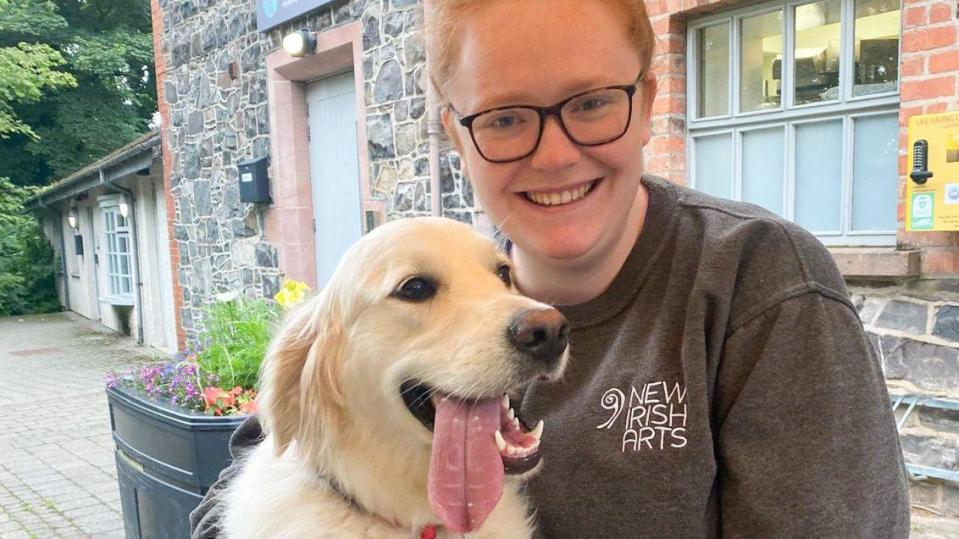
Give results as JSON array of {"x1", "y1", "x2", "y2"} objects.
[{"x1": 742, "y1": 127, "x2": 784, "y2": 216}]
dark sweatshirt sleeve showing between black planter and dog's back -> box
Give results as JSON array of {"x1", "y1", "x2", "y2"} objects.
[{"x1": 190, "y1": 416, "x2": 263, "y2": 539}]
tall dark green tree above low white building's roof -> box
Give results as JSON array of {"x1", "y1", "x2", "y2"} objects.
[{"x1": 0, "y1": 0, "x2": 156, "y2": 185}]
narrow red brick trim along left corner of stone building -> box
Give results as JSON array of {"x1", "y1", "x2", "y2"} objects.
[{"x1": 150, "y1": 0, "x2": 186, "y2": 350}]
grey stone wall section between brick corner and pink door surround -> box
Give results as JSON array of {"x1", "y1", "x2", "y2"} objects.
[{"x1": 157, "y1": 0, "x2": 279, "y2": 344}]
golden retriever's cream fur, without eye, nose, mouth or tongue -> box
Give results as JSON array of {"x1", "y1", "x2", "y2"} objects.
[{"x1": 223, "y1": 218, "x2": 566, "y2": 539}]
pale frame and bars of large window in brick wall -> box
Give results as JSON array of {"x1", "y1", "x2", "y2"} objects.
[{"x1": 686, "y1": 0, "x2": 903, "y2": 246}]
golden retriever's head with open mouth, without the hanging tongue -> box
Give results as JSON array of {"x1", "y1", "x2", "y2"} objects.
[{"x1": 259, "y1": 218, "x2": 568, "y2": 532}]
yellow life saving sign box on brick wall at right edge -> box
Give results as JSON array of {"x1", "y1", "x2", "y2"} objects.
[{"x1": 906, "y1": 112, "x2": 959, "y2": 230}]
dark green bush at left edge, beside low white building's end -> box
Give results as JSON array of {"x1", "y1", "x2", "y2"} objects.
[{"x1": 0, "y1": 178, "x2": 60, "y2": 316}]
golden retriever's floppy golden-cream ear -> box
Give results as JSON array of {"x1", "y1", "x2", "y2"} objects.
[{"x1": 257, "y1": 287, "x2": 343, "y2": 455}]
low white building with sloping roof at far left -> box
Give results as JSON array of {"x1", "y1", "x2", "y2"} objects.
[{"x1": 27, "y1": 132, "x2": 177, "y2": 352}]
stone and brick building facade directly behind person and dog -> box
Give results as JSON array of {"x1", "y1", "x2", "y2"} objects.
[{"x1": 153, "y1": 0, "x2": 959, "y2": 515}]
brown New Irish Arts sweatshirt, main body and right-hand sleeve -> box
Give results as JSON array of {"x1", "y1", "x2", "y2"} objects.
[{"x1": 522, "y1": 177, "x2": 909, "y2": 538}]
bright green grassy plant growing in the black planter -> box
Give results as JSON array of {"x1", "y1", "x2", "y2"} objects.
[{"x1": 196, "y1": 295, "x2": 282, "y2": 389}]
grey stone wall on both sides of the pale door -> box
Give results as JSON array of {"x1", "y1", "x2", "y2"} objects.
[{"x1": 158, "y1": 0, "x2": 473, "y2": 342}]
